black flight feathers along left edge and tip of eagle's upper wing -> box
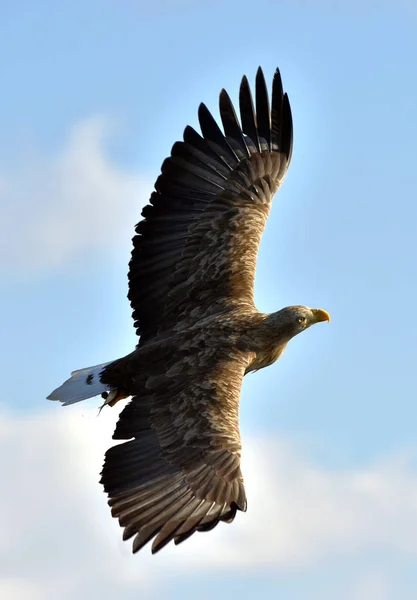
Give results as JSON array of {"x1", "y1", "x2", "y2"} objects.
[{"x1": 129, "y1": 68, "x2": 292, "y2": 343}]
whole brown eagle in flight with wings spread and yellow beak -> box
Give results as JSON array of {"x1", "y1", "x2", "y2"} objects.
[{"x1": 48, "y1": 68, "x2": 330, "y2": 553}]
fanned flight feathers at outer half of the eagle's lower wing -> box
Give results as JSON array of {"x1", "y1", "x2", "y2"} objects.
[{"x1": 101, "y1": 422, "x2": 246, "y2": 553}]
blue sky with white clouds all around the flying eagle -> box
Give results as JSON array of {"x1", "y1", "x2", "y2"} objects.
[{"x1": 0, "y1": 0, "x2": 417, "y2": 600}]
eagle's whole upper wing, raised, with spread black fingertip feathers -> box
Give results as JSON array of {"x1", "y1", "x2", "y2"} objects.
[{"x1": 129, "y1": 69, "x2": 292, "y2": 343}]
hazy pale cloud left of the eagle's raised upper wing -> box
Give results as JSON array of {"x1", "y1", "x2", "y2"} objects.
[{"x1": 0, "y1": 117, "x2": 152, "y2": 272}]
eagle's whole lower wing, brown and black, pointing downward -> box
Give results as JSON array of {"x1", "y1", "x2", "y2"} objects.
[{"x1": 101, "y1": 344, "x2": 248, "y2": 552}]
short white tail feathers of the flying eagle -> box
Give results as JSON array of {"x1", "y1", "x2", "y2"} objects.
[{"x1": 48, "y1": 361, "x2": 113, "y2": 406}]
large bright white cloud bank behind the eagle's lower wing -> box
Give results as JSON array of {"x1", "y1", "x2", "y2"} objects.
[{"x1": 0, "y1": 406, "x2": 417, "y2": 600}]
